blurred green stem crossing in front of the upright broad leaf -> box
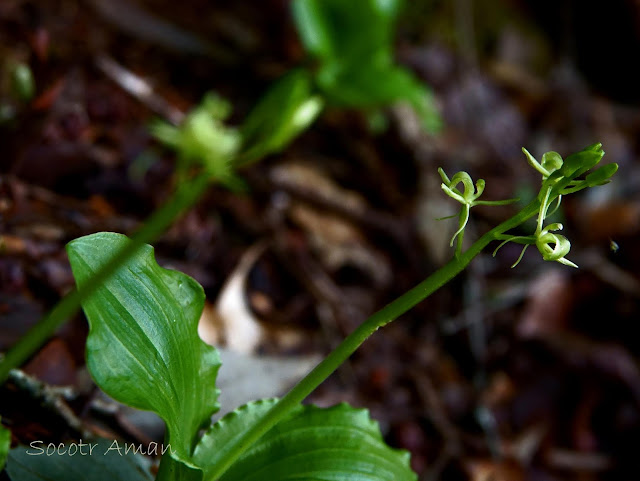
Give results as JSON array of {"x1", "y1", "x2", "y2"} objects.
[{"x1": 0, "y1": 174, "x2": 210, "y2": 385}]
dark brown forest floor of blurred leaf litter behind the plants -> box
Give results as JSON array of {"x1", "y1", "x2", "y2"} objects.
[{"x1": 0, "y1": 0, "x2": 640, "y2": 481}]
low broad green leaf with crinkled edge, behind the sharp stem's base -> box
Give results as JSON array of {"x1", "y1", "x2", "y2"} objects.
[{"x1": 194, "y1": 400, "x2": 417, "y2": 481}]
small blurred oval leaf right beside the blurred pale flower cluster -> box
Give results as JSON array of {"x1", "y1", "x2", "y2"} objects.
[{"x1": 241, "y1": 69, "x2": 322, "y2": 163}]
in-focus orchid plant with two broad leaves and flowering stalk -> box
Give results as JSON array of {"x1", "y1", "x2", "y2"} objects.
[{"x1": 2, "y1": 144, "x2": 617, "y2": 481}]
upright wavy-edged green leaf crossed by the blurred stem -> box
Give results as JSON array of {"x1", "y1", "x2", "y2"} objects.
[{"x1": 67, "y1": 232, "x2": 220, "y2": 460}]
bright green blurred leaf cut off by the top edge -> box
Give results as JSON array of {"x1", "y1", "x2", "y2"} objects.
[{"x1": 293, "y1": 0, "x2": 440, "y2": 131}]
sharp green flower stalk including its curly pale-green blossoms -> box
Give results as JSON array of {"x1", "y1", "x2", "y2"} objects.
[{"x1": 209, "y1": 144, "x2": 617, "y2": 480}]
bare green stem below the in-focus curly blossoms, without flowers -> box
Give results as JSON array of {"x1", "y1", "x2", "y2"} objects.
[{"x1": 208, "y1": 199, "x2": 540, "y2": 480}]
